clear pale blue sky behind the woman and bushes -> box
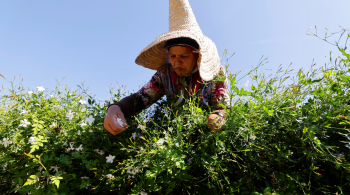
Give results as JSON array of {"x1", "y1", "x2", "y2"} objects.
[{"x1": 0, "y1": 0, "x2": 350, "y2": 100}]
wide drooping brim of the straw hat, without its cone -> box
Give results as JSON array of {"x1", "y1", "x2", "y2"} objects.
[{"x1": 135, "y1": 30, "x2": 220, "y2": 81}]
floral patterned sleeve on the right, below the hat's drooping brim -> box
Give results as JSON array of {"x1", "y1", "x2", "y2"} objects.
[{"x1": 211, "y1": 66, "x2": 230, "y2": 110}]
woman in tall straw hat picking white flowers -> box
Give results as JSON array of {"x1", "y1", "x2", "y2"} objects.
[{"x1": 104, "y1": 0, "x2": 229, "y2": 135}]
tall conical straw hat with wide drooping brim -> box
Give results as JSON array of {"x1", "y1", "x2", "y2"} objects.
[{"x1": 135, "y1": 0, "x2": 220, "y2": 81}]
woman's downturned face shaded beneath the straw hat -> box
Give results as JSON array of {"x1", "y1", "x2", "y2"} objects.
[{"x1": 169, "y1": 46, "x2": 197, "y2": 76}]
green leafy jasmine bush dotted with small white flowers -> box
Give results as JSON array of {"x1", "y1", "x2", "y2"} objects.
[{"x1": 0, "y1": 30, "x2": 350, "y2": 195}]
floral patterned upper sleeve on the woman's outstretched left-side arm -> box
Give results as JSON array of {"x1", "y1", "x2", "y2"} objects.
[{"x1": 137, "y1": 72, "x2": 165, "y2": 108}]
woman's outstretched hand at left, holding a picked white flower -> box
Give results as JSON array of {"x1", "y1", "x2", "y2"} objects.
[{"x1": 104, "y1": 105, "x2": 128, "y2": 135}]
